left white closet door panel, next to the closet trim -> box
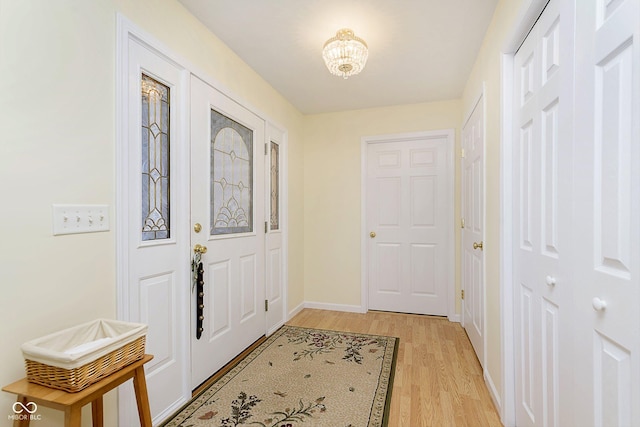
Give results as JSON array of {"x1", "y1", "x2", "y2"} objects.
[{"x1": 512, "y1": 0, "x2": 575, "y2": 426}]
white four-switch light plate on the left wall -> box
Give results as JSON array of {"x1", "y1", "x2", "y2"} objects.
[{"x1": 53, "y1": 204, "x2": 109, "y2": 236}]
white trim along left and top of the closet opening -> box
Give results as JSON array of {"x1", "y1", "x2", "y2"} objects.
[{"x1": 499, "y1": 0, "x2": 548, "y2": 426}]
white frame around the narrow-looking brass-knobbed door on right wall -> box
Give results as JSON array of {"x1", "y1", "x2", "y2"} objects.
[{"x1": 460, "y1": 88, "x2": 487, "y2": 368}]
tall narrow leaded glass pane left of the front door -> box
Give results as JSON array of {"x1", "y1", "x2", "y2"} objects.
[{"x1": 141, "y1": 74, "x2": 170, "y2": 240}]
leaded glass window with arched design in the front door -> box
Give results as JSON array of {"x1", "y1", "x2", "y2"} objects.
[{"x1": 211, "y1": 110, "x2": 253, "y2": 235}]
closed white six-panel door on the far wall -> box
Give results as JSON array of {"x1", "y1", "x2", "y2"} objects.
[{"x1": 366, "y1": 133, "x2": 453, "y2": 315}]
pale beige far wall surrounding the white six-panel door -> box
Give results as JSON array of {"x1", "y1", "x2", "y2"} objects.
[{"x1": 304, "y1": 101, "x2": 462, "y2": 306}]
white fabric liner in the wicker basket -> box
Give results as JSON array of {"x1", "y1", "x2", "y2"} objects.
[{"x1": 22, "y1": 319, "x2": 147, "y2": 369}]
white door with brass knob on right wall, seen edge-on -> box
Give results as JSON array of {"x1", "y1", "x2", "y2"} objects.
[{"x1": 462, "y1": 97, "x2": 485, "y2": 366}]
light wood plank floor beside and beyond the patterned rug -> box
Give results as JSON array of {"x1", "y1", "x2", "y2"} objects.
[{"x1": 287, "y1": 309, "x2": 502, "y2": 427}]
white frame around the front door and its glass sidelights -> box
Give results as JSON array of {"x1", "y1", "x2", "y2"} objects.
[{"x1": 114, "y1": 12, "x2": 289, "y2": 425}]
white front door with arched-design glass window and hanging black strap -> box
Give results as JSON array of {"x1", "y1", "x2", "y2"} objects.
[{"x1": 191, "y1": 77, "x2": 266, "y2": 387}]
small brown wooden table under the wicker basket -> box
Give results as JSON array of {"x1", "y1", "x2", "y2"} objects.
[{"x1": 2, "y1": 354, "x2": 153, "y2": 427}]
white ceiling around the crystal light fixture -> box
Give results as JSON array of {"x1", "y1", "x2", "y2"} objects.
[{"x1": 179, "y1": 0, "x2": 498, "y2": 114}]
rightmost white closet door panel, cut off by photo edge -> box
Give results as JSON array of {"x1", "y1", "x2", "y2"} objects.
[{"x1": 573, "y1": 0, "x2": 640, "y2": 426}]
